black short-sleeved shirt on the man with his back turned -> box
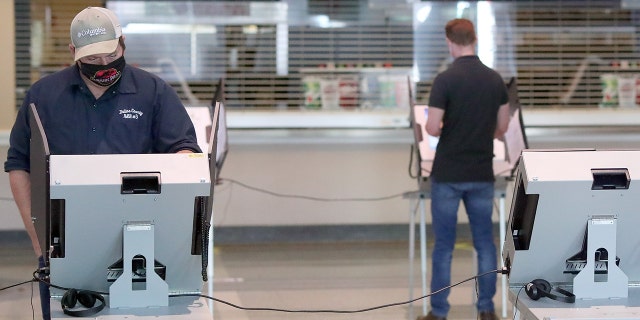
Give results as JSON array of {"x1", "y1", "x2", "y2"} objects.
[{"x1": 429, "y1": 55, "x2": 508, "y2": 182}]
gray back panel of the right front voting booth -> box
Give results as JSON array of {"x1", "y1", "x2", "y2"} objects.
[{"x1": 502, "y1": 150, "x2": 640, "y2": 286}]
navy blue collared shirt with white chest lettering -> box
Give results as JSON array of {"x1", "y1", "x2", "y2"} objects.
[{"x1": 4, "y1": 65, "x2": 201, "y2": 171}]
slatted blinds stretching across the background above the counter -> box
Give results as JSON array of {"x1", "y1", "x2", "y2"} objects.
[{"x1": 15, "y1": 0, "x2": 640, "y2": 111}]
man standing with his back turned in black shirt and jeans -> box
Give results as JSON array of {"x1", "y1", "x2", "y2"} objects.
[{"x1": 418, "y1": 19, "x2": 509, "y2": 320}]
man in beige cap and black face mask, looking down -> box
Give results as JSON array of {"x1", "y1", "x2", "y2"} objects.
[{"x1": 4, "y1": 7, "x2": 201, "y2": 320}]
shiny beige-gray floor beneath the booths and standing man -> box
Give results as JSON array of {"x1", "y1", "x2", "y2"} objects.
[{"x1": 0, "y1": 238, "x2": 511, "y2": 320}]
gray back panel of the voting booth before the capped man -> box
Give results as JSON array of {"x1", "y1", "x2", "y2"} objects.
[{"x1": 50, "y1": 154, "x2": 211, "y2": 302}]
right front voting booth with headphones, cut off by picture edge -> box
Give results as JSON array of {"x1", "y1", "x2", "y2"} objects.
[{"x1": 502, "y1": 150, "x2": 640, "y2": 319}]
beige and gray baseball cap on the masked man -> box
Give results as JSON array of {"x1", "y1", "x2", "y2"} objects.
[{"x1": 70, "y1": 7, "x2": 122, "y2": 61}]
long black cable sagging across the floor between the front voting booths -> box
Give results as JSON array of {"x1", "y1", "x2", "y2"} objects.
[{"x1": 10, "y1": 268, "x2": 509, "y2": 314}]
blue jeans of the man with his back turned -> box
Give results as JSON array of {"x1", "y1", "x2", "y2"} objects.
[{"x1": 431, "y1": 180, "x2": 498, "y2": 317}]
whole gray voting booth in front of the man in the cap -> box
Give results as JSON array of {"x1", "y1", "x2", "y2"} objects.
[{"x1": 30, "y1": 105, "x2": 221, "y2": 319}]
